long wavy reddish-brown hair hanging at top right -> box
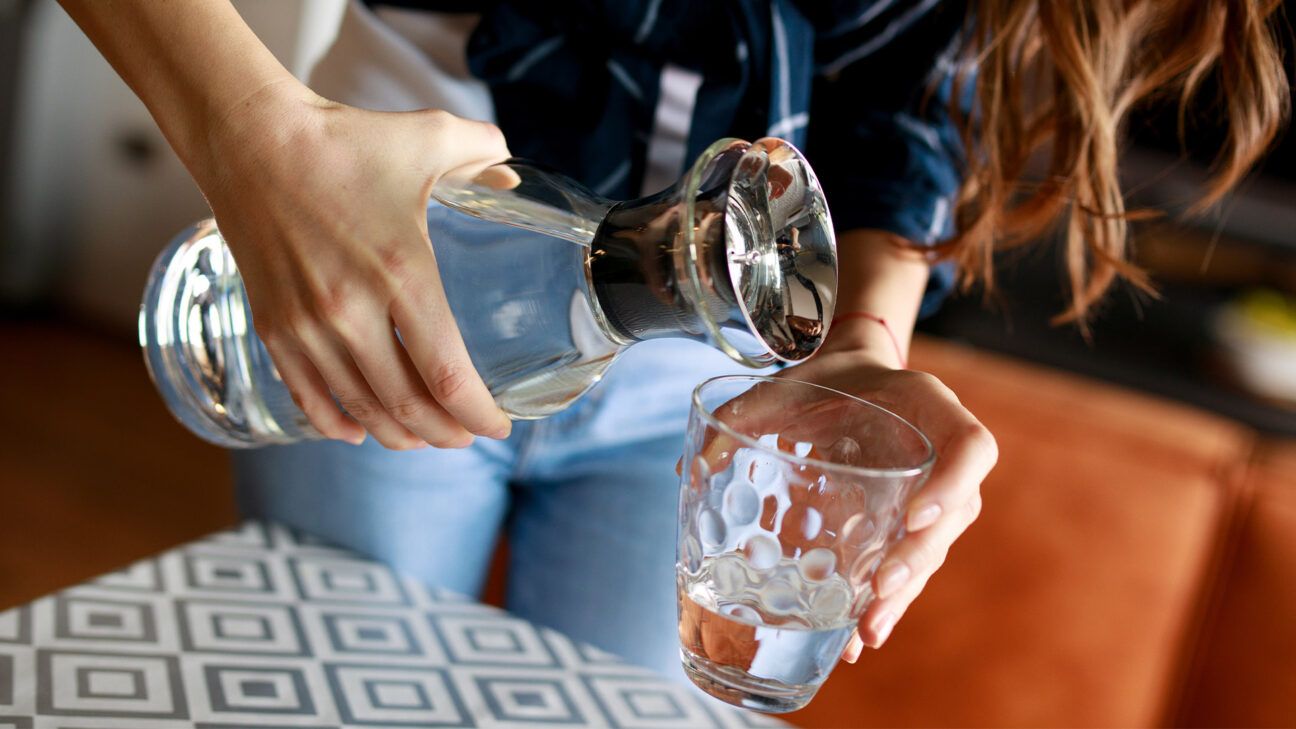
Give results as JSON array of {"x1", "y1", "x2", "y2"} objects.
[{"x1": 941, "y1": 0, "x2": 1291, "y2": 327}]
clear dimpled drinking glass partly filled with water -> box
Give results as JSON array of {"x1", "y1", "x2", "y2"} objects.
[{"x1": 675, "y1": 376, "x2": 936, "y2": 712}]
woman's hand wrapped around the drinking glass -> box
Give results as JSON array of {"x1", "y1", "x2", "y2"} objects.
[{"x1": 780, "y1": 346, "x2": 998, "y2": 663}]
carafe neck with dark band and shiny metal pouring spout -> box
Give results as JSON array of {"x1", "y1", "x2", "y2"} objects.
[{"x1": 587, "y1": 139, "x2": 837, "y2": 367}]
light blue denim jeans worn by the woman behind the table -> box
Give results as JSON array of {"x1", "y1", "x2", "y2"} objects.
[{"x1": 235, "y1": 340, "x2": 745, "y2": 678}]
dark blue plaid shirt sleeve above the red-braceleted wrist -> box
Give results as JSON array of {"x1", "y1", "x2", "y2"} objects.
[{"x1": 806, "y1": 0, "x2": 966, "y2": 317}]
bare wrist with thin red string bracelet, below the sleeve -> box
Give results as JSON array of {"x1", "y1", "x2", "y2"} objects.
[{"x1": 823, "y1": 230, "x2": 931, "y2": 367}]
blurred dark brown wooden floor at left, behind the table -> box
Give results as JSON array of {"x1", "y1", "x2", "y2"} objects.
[{"x1": 0, "y1": 320, "x2": 236, "y2": 608}]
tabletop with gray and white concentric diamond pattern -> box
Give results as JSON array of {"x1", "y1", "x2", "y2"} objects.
[{"x1": 0, "y1": 521, "x2": 783, "y2": 729}]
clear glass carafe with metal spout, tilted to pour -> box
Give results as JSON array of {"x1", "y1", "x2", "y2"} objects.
[{"x1": 140, "y1": 139, "x2": 837, "y2": 448}]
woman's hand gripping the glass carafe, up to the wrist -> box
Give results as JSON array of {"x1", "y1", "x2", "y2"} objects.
[{"x1": 194, "y1": 79, "x2": 511, "y2": 449}]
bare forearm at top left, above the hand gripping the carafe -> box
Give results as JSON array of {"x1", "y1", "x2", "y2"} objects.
[{"x1": 60, "y1": 0, "x2": 312, "y2": 176}]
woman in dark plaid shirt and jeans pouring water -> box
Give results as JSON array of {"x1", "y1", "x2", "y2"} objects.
[{"x1": 64, "y1": 0, "x2": 1288, "y2": 671}]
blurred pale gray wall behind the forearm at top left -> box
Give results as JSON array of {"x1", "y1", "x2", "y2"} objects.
[{"x1": 0, "y1": 0, "x2": 345, "y2": 327}]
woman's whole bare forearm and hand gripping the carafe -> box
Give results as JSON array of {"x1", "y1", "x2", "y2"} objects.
[{"x1": 62, "y1": 0, "x2": 511, "y2": 448}]
